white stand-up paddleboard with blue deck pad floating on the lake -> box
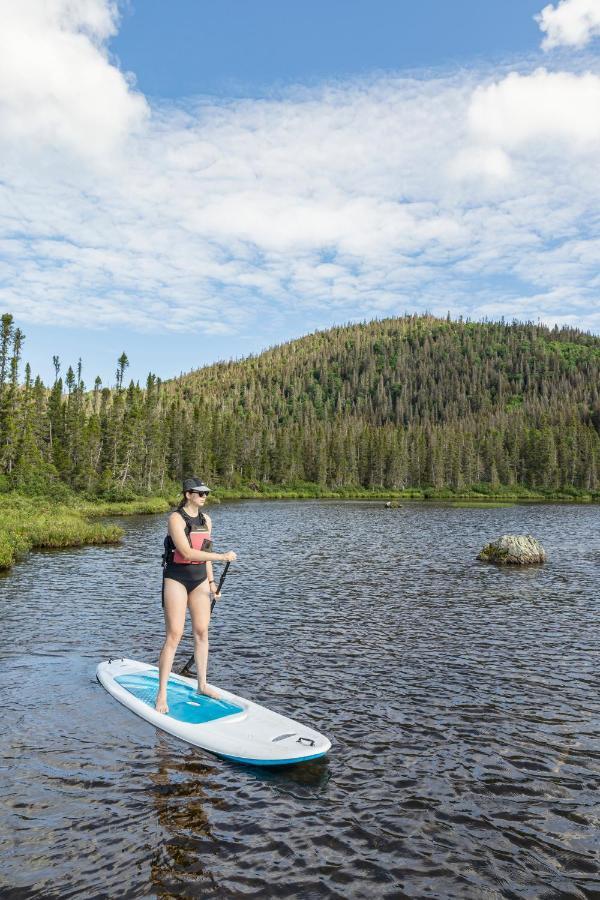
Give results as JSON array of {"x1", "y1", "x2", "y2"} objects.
[{"x1": 96, "y1": 659, "x2": 331, "y2": 766}]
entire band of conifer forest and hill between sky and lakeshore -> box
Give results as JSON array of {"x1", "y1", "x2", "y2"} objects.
[{"x1": 0, "y1": 316, "x2": 600, "y2": 496}]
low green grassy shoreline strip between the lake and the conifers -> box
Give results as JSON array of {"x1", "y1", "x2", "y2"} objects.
[{"x1": 0, "y1": 483, "x2": 600, "y2": 570}]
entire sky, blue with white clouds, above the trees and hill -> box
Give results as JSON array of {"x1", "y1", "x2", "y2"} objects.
[{"x1": 0, "y1": 0, "x2": 600, "y2": 385}]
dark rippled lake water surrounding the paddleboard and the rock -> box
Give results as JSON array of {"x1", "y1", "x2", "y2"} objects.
[{"x1": 0, "y1": 502, "x2": 600, "y2": 900}]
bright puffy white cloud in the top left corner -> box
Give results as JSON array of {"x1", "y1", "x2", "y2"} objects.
[{"x1": 0, "y1": 0, "x2": 148, "y2": 160}]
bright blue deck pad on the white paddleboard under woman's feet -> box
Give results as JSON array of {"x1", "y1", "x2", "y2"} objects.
[{"x1": 115, "y1": 672, "x2": 243, "y2": 725}]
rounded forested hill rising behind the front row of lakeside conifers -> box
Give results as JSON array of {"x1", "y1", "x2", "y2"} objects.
[{"x1": 178, "y1": 317, "x2": 600, "y2": 426}]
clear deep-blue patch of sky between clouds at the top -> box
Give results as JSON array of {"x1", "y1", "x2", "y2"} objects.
[{"x1": 111, "y1": 0, "x2": 543, "y2": 100}]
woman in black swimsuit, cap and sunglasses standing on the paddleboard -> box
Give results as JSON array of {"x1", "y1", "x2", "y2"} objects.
[{"x1": 156, "y1": 478, "x2": 237, "y2": 713}]
